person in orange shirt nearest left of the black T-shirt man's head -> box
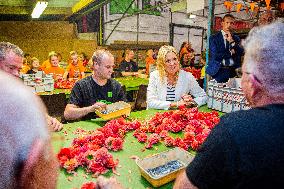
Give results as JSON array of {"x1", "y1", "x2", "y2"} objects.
[{"x1": 63, "y1": 51, "x2": 85, "y2": 79}]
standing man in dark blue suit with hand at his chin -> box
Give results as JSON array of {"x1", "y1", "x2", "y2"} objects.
[{"x1": 206, "y1": 14, "x2": 243, "y2": 83}]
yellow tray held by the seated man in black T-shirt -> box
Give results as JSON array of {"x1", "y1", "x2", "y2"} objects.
[{"x1": 96, "y1": 101, "x2": 131, "y2": 120}]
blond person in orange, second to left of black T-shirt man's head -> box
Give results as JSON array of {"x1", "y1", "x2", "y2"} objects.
[{"x1": 45, "y1": 53, "x2": 64, "y2": 81}]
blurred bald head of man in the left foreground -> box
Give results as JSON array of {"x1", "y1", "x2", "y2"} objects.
[{"x1": 0, "y1": 71, "x2": 59, "y2": 189}]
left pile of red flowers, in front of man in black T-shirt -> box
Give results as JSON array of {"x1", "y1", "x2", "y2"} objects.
[{"x1": 57, "y1": 118, "x2": 141, "y2": 176}]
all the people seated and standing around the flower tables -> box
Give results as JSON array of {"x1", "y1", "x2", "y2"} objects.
[{"x1": 0, "y1": 11, "x2": 284, "y2": 189}]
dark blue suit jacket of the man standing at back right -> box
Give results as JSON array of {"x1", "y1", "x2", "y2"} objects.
[{"x1": 206, "y1": 31, "x2": 244, "y2": 78}]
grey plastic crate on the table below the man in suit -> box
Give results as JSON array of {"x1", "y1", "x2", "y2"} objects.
[{"x1": 207, "y1": 78, "x2": 250, "y2": 113}]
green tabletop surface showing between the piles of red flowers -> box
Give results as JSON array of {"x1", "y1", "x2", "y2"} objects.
[{"x1": 52, "y1": 106, "x2": 222, "y2": 189}]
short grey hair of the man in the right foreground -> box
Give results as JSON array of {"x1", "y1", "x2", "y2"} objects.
[{"x1": 244, "y1": 21, "x2": 284, "y2": 94}]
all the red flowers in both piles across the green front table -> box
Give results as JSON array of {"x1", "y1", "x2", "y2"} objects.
[{"x1": 57, "y1": 107, "x2": 219, "y2": 176}]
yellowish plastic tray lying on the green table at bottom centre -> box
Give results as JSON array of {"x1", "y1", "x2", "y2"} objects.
[{"x1": 136, "y1": 147, "x2": 194, "y2": 187}]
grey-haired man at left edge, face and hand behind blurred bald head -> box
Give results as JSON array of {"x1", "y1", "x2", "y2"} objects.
[{"x1": 0, "y1": 42, "x2": 63, "y2": 131}]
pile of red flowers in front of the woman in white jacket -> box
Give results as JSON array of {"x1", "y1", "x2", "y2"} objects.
[{"x1": 133, "y1": 107, "x2": 219, "y2": 150}]
